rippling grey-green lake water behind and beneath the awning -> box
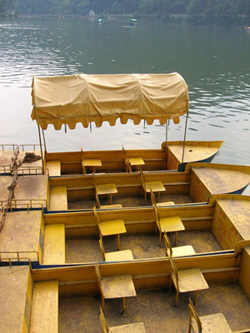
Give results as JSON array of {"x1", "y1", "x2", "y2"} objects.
[{"x1": 0, "y1": 18, "x2": 250, "y2": 174}]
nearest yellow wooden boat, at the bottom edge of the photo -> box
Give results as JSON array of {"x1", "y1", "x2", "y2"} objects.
[{"x1": 0, "y1": 237, "x2": 250, "y2": 333}]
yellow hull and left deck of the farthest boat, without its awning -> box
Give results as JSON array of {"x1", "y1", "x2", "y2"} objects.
[{"x1": 0, "y1": 141, "x2": 223, "y2": 177}]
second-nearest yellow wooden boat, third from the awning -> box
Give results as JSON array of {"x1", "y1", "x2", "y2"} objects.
[{"x1": 0, "y1": 195, "x2": 250, "y2": 265}]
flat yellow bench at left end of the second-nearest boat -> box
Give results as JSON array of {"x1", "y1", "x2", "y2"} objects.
[{"x1": 43, "y1": 224, "x2": 65, "y2": 265}]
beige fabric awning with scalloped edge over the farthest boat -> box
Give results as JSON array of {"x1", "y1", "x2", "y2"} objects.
[{"x1": 31, "y1": 73, "x2": 189, "y2": 130}]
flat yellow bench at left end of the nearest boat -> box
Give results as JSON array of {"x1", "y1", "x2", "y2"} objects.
[{"x1": 30, "y1": 281, "x2": 59, "y2": 333}]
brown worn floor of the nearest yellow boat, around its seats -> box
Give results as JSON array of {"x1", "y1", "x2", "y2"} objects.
[{"x1": 59, "y1": 282, "x2": 250, "y2": 333}]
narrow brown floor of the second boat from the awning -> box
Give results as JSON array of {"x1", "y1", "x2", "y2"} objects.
[{"x1": 68, "y1": 194, "x2": 193, "y2": 209}]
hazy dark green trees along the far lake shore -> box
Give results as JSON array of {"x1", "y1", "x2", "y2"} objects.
[{"x1": 0, "y1": 0, "x2": 250, "y2": 25}]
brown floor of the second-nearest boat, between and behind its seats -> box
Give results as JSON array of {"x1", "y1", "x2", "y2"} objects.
[{"x1": 66, "y1": 230, "x2": 221, "y2": 263}]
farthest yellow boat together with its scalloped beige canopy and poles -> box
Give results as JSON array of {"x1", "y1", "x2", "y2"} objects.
[{"x1": 28, "y1": 73, "x2": 223, "y2": 176}]
